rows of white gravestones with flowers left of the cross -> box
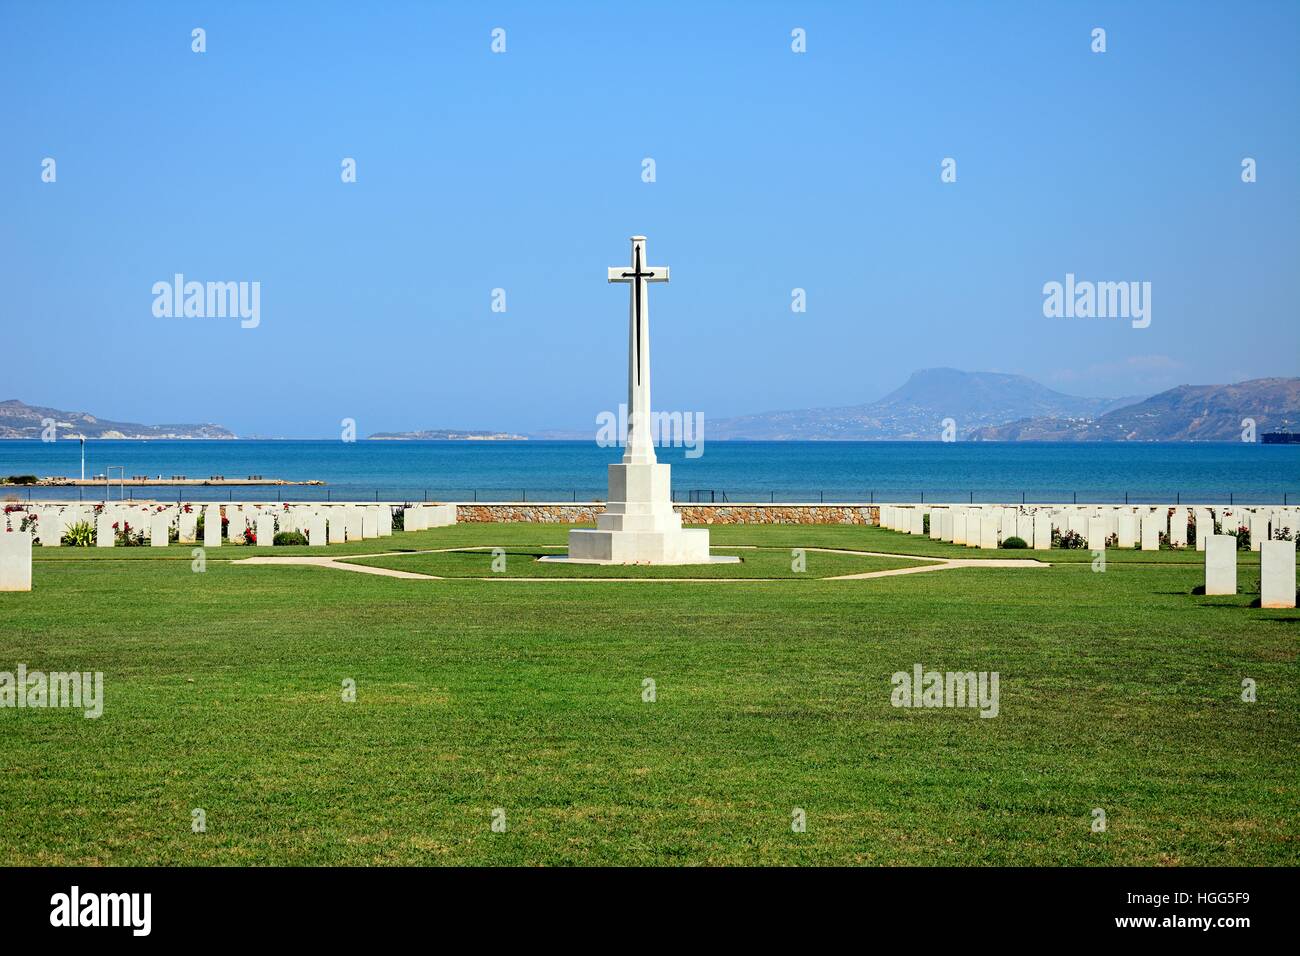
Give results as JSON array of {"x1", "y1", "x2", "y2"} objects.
[{"x1": 0, "y1": 502, "x2": 456, "y2": 548}]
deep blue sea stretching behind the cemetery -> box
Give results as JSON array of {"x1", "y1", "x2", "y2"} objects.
[{"x1": 0, "y1": 440, "x2": 1300, "y2": 503}]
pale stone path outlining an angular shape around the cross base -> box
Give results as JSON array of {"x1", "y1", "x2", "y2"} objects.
[{"x1": 230, "y1": 545, "x2": 1052, "y2": 584}]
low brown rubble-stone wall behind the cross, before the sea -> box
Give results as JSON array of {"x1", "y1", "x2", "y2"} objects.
[{"x1": 456, "y1": 502, "x2": 879, "y2": 524}]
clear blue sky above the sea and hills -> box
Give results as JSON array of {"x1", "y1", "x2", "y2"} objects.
[{"x1": 0, "y1": 0, "x2": 1300, "y2": 437}]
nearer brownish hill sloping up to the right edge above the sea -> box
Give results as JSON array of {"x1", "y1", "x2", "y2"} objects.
[{"x1": 971, "y1": 378, "x2": 1300, "y2": 441}]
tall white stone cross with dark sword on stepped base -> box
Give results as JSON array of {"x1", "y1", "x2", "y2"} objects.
[{"x1": 561, "y1": 235, "x2": 740, "y2": 564}]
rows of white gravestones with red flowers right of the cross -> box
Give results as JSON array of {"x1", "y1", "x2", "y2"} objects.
[{"x1": 879, "y1": 505, "x2": 1300, "y2": 551}]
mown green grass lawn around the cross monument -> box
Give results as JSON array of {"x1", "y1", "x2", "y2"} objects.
[{"x1": 0, "y1": 524, "x2": 1300, "y2": 865}]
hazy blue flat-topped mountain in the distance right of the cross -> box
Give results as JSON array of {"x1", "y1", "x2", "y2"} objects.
[{"x1": 707, "y1": 368, "x2": 1141, "y2": 441}]
